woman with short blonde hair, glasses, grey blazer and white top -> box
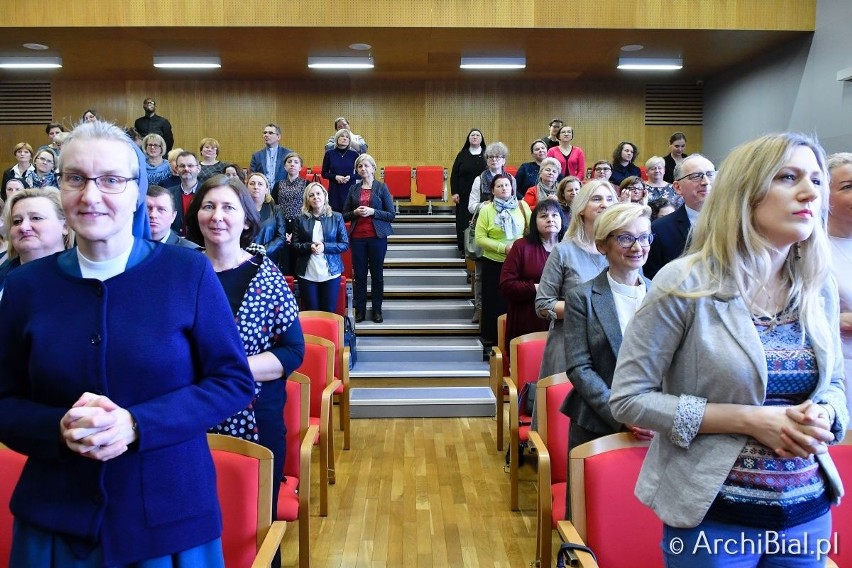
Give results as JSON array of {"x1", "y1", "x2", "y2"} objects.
[{"x1": 561, "y1": 203, "x2": 654, "y2": 452}]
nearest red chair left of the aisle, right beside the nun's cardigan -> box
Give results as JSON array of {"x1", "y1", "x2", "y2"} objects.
[{"x1": 207, "y1": 434, "x2": 287, "y2": 567}]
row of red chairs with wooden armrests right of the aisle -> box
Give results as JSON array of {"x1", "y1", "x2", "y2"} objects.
[{"x1": 491, "y1": 322, "x2": 852, "y2": 567}]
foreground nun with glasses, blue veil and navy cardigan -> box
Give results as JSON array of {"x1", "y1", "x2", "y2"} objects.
[{"x1": 0, "y1": 121, "x2": 254, "y2": 568}]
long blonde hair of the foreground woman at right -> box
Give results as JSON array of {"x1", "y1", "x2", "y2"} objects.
[{"x1": 670, "y1": 132, "x2": 832, "y2": 347}]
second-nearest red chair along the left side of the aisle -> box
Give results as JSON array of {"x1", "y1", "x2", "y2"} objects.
[{"x1": 277, "y1": 373, "x2": 319, "y2": 568}]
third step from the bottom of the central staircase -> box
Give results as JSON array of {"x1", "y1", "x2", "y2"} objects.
[{"x1": 352, "y1": 336, "x2": 482, "y2": 362}]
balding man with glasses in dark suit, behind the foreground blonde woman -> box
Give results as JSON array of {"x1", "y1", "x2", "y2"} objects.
[{"x1": 644, "y1": 154, "x2": 716, "y2": 278}]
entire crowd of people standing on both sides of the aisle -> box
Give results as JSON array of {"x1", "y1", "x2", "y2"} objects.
[{"x1": 0, "y1": 98, "x2": 852, "y2": 566}]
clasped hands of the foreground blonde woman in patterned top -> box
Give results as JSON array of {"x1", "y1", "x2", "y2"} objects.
[{"x1": 754, "y1": 400, "x2": 834, "y2": 458}]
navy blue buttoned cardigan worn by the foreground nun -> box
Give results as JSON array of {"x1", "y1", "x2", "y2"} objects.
[{"x1": 0, "y1": 243, "x2": 254, "y2": 565}]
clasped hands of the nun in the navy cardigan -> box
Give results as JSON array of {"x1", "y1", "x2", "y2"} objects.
[{"x1": 59, "y1": 392, "x2": 137, "y2": 461}]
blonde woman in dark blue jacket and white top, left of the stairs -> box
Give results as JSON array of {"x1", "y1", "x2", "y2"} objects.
[{"x1": 293, "y1": 182, "x2": 349, "y2": 313}]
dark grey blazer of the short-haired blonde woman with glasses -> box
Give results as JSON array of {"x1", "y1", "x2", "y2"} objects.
[{"x1": 560, "y1": 269, "x2": 651, "y2": 434}]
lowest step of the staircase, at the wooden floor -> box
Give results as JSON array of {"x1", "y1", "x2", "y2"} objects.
[{"x1": 349, "y1": 387, "x2": 495, "y2": 418}]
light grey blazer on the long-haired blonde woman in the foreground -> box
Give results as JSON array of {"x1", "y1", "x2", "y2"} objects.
[{"x1": 610, "y1": 256, "x2": 849, "y2": 527}]
